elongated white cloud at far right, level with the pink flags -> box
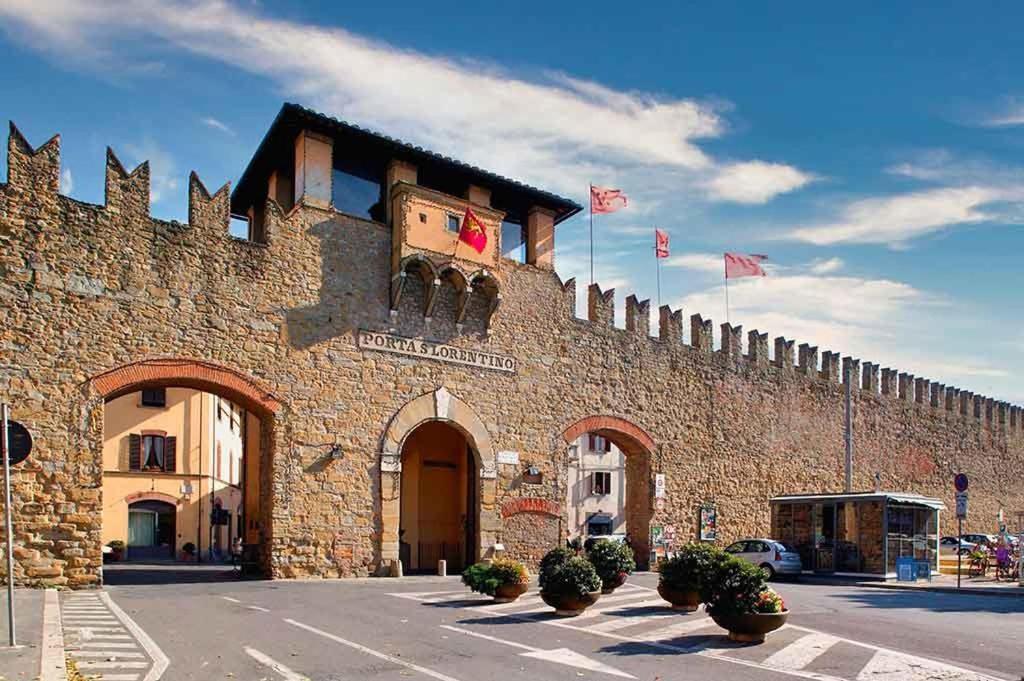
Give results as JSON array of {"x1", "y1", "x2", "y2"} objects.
[{"x1": 786, "y1": 185, "x2": 1024, "y2": 246}]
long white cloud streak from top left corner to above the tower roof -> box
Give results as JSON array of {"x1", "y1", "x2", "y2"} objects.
[{"x1": 0, "y1": 0, "x2": 807, "y2": 206}]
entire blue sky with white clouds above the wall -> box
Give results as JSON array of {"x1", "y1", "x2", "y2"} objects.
[{"x1": 0, "y1": 0, "x2": 1024, "y2": 403}]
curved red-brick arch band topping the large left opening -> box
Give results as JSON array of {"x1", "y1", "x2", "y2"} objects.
[{"x1": 90, "y1": 357, "x2": 281, "y2": 416}]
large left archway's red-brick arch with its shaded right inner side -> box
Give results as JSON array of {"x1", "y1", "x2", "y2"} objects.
[{"x1": 82, "y1": 357, "x2": 283, "y2": 576}]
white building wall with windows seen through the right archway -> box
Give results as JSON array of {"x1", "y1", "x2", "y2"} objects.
[{"x1": 566, "y1": 434, "x2": 626, "y2": 539}]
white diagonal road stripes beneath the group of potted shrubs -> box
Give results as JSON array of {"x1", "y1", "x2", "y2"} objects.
[{"x1": 390, "y1": 585, "x2": 998, "y2": 681}]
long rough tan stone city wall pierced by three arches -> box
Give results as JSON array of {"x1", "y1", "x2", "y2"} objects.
[{"x1": 0, "y1": 123, "x2": 1024, "y2": 586}]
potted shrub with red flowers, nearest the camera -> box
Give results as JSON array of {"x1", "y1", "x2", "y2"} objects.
[{"x1": 703, "y1": 556, "x2": 790, "y2": 643}]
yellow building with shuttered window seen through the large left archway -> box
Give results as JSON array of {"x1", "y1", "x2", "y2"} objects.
[{"x1": 102, "y1": 387, "x2": 252, "y2": 562}]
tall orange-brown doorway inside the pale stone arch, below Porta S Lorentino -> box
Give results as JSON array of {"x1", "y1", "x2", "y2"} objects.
[{"x1": 398, "y1": 421, "x2": 479, "y2": 572}]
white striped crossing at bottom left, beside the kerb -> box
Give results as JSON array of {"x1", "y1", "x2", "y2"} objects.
[{"x1": 60, "y1": 591, "x2": 162, "y2": 681}]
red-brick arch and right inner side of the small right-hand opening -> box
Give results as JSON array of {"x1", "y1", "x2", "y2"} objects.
[{"x1": 562, "y1": 416, "x2": 655, "y2": 569}]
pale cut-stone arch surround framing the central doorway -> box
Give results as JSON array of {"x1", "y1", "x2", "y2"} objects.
[{"x1": 380, "y1": 387, "x2": 501, "y2": 570}]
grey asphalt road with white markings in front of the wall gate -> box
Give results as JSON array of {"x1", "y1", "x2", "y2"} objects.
[{"x1": 75, "y1": 574, "x2": 1024, "y2": 681}]
